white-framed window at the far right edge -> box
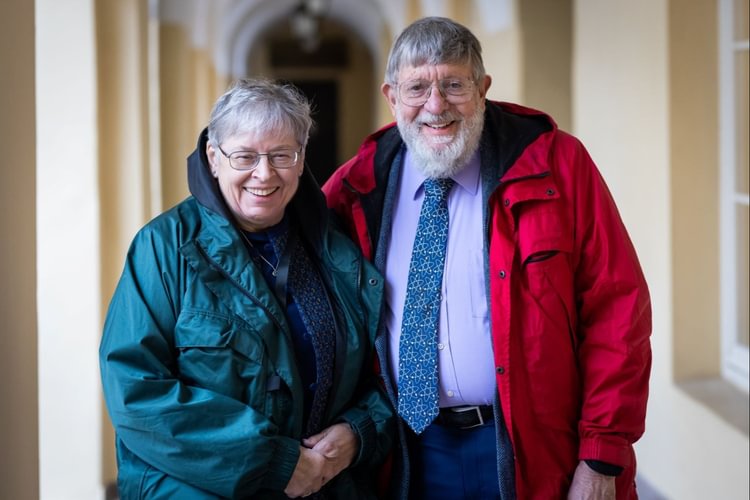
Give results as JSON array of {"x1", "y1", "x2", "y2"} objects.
[{"x1": 719, "y1": 0, "x2": 750, "y2": 391}]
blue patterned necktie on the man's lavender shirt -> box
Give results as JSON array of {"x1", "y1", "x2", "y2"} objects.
[{"x1": 398, "y1": 179, "x2": 453, "y2": 434}]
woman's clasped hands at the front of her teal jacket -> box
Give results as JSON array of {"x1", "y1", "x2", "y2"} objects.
[{"x1": 284, "y1": 423, "x2": 359, "y2": 498}]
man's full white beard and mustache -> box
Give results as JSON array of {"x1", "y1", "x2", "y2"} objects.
[{"x1": 397, "y1": 105, "x2": 484, "y2": 179}]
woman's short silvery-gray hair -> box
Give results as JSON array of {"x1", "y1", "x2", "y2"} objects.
[{"x1": 208, "y1": 78, "x2": 313, "y2": 149}]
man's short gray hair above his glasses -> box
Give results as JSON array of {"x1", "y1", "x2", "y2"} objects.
[{"x1": 385, "y1": 17, "x2": 485, "y2": 85}]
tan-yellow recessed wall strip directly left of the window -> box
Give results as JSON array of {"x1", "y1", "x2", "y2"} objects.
[{"x1": 669, "y1": 2, "x2": 720, "y2": 380}]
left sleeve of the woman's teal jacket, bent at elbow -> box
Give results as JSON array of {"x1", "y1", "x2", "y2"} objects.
[{"x1": 99, "y1": 229, "x2": 299, "y2": 497}]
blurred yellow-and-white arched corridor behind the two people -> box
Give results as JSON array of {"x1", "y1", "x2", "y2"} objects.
[{"x1": 0, "y1": 0, "x2": 750, "y2": 500}]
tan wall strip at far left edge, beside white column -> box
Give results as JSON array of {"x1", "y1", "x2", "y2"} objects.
[{"x1": 0, "y1": 0, "x2": 39, "y2": 498}]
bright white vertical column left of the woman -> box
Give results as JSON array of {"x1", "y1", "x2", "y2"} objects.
[{"x1": 36, "y1": 0, "x2": 103, "y2": 500}]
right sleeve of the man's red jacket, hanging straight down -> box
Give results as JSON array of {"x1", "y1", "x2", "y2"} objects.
[{"x1": 558, "y1": 135, "x2": 651, "y2": 467}]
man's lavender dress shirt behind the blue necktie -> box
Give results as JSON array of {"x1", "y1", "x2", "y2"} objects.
[{"x1": 385, "y1": 150, "x2": 496, "y2": 407}]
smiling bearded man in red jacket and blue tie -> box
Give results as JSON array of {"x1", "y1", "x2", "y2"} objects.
[{"x1": 324, "y1": 18, "x2": 651, "y2": 500}]
